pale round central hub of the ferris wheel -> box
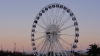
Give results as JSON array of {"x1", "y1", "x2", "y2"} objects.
[{"x1": 46, "y1": 24, "x2": 60, "y2": 42}]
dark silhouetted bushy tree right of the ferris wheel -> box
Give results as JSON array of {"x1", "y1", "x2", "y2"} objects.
[{"x1": 87, "y1": 44, "x2": 100, "y2": 56}]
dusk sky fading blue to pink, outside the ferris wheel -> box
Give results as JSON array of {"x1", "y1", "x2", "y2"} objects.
[{"x1": 0, "y1": 0, "x2": 100, "y2": 52}]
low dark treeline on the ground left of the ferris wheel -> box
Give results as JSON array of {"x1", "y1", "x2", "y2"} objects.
[{"x1": 0, "y1": 50, "x2": 35, "y2": 56}]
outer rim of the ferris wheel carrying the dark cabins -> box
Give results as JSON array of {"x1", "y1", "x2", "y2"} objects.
[{"x1": 31, "y1": 3, "x2": 79, "y2": 55}]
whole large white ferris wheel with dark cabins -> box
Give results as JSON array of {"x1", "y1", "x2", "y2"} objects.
[{"x1": 31, "y1": 3, "x2": 79, "y2": 56}]
